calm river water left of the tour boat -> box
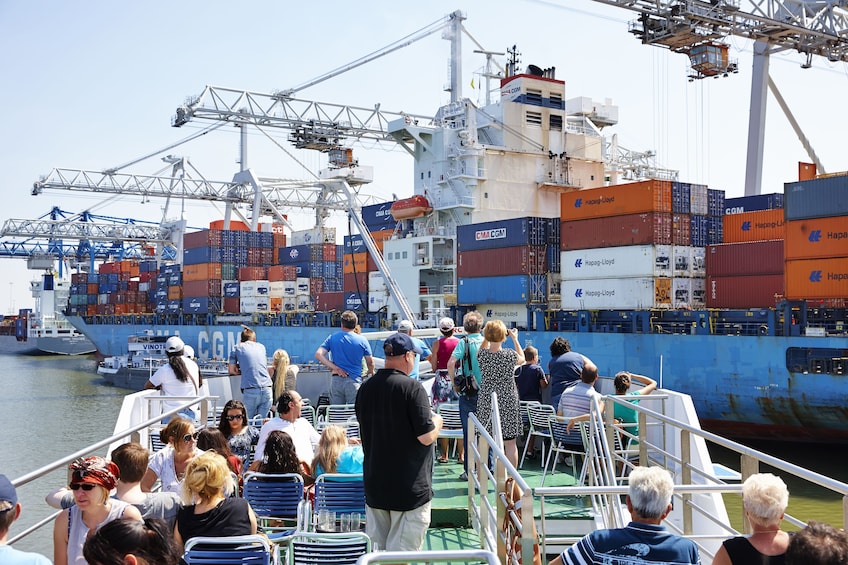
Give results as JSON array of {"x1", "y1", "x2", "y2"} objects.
[{"x1": 0, "y1": 336, "x2": 127, "y2": 559}]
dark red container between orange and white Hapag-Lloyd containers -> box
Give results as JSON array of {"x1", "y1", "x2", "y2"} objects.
[{"x1": 560, "y1": 213, "x2": 672, "y2": 251}]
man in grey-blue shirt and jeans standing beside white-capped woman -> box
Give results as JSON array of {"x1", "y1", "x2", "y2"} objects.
[{"x1": 228, "y1": 326, "x2": 274, "y2": 418}]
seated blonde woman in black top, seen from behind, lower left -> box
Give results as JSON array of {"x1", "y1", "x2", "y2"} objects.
[{"x1": 174, "y1": 451, "x2": 256, "y2": 553}]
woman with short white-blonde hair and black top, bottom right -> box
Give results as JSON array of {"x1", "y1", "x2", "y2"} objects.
[{"x1": 713, "y1": 473, "x2": 789, "y2": 565}]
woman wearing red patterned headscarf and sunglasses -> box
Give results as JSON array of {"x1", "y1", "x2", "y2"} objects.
[{"x1": 53, "y1": 457, "x2": 141, "y2": 565}]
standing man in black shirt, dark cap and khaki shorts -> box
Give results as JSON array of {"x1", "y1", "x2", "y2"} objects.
[{"x1": 356, "y1": 333, "x2": 442, "y2": 551}]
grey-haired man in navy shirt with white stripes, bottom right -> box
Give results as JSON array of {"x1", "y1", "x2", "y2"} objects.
[{"x1": 549, "y1": 467, "x2": 701, "y2": 565}]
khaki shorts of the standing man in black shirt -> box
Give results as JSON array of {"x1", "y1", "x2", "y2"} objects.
[{"x1": 365, "y1": 501, "x2": 430, "y2": 551}]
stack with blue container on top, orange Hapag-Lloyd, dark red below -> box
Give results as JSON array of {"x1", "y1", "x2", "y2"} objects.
[{"x1": 705, "y1": 194, "x2": 784, "y2": 308}]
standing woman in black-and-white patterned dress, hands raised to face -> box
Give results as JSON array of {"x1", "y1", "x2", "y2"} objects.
[{"x1": 477, "y1": 320, "x2": 524, "y2": 467}]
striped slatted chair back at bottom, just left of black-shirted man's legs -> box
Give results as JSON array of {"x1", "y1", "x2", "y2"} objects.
[{"x1": 286, "y1": 532, "x2": 371, "y2": 565}]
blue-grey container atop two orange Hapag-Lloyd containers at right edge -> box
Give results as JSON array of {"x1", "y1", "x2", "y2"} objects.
[{"x1": 784, "y1": 176, "x2": 848, "y2": 300}]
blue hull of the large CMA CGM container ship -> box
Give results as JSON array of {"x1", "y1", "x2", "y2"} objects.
[{"x1": 69, "y1": 316, "x2": 848, "y2": 442}]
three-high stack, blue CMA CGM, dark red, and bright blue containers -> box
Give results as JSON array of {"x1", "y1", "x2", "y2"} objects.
[{"x1": 456, "y1": 217, "x2": 557, "y2": 309}]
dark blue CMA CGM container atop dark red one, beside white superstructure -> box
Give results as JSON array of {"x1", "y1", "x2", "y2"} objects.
[{"x1": 456, "y1": 218, "x2": 548, "y2": 251}]
